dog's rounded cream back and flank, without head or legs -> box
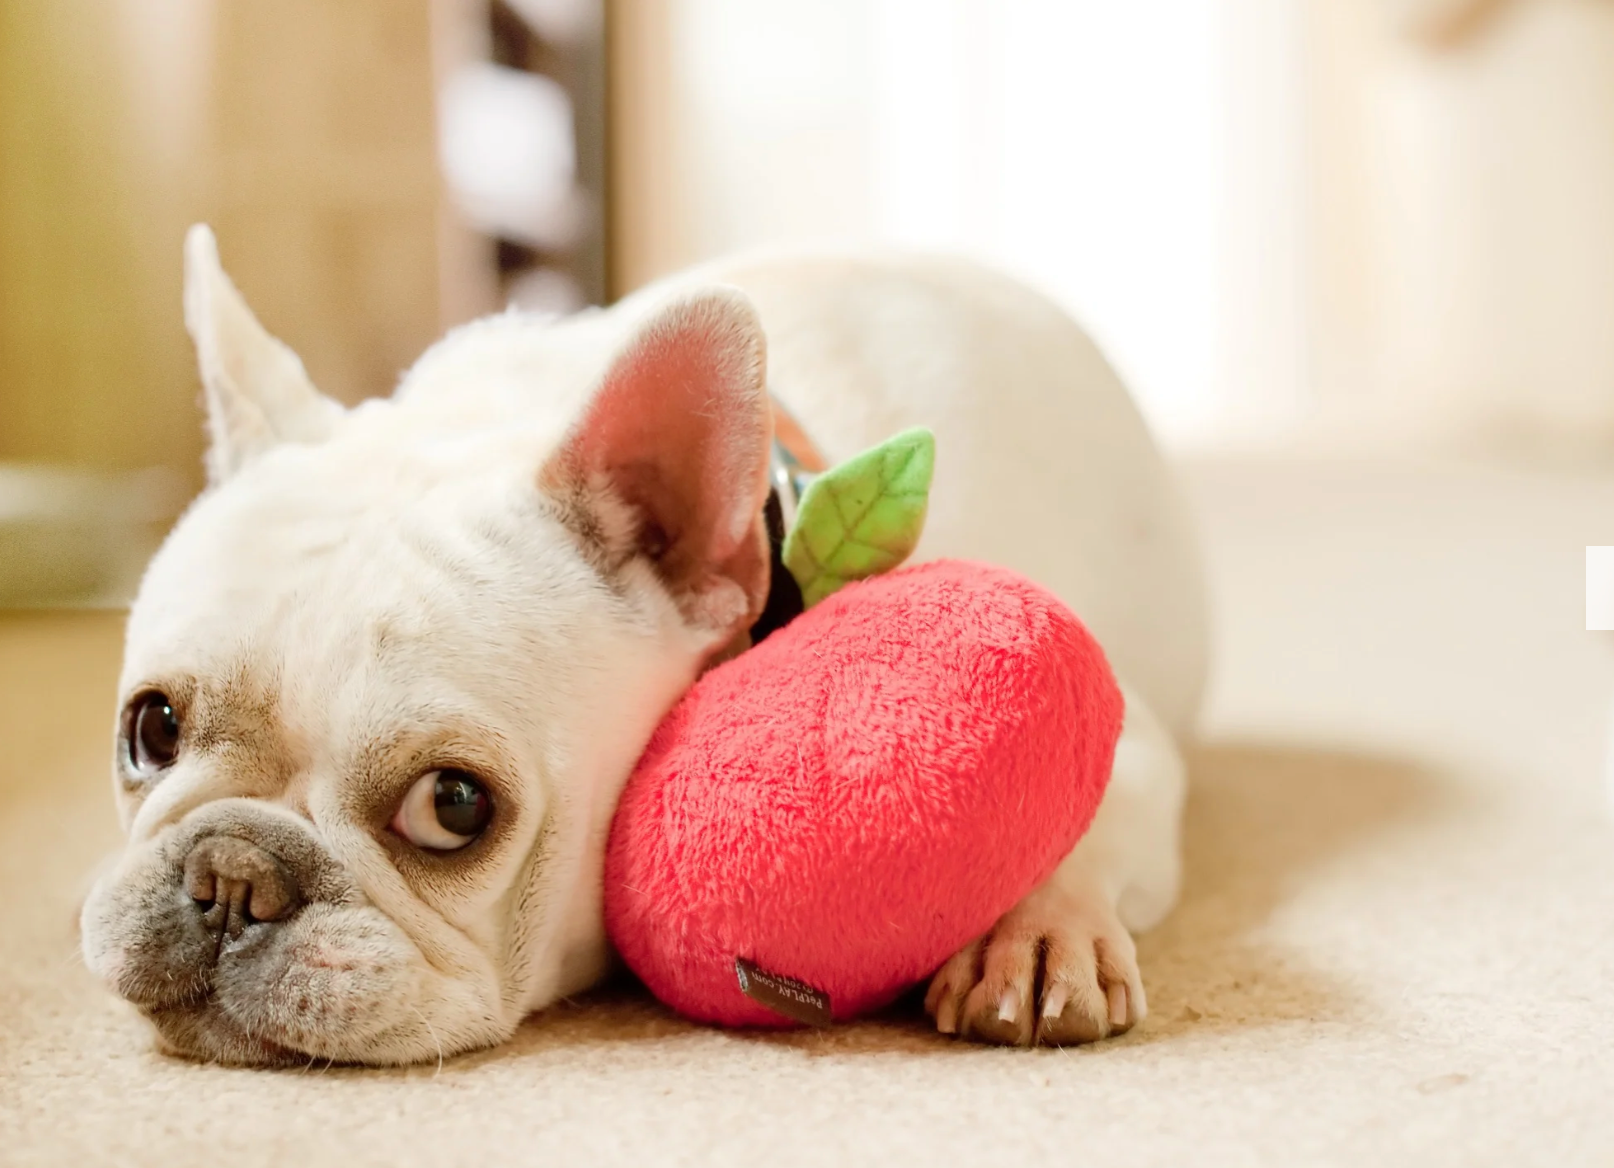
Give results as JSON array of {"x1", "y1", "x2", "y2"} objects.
[{"x1": 677, "y1": 255, "x2": 1206, "y2": 736}]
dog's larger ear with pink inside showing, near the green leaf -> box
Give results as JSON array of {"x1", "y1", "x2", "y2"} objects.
[{"x1": 541, "y1": 286, "x2": 773, "y2": 634}]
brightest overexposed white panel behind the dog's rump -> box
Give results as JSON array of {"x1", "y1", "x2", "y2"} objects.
[{"x1": 867, "y1": 0, "x2": 1228, "y2": 448}]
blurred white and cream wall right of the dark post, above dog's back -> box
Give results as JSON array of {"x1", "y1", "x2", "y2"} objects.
[{"x1": 618, "y1": 0, "x2": 1614, "y2": 458}]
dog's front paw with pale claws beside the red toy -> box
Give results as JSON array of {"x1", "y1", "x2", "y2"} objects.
[{"x1": 925, "y1": 874, "x2": 1146, "y2": 1047}]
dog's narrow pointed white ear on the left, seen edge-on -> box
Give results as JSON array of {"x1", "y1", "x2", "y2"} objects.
[{"x1": 186, "y1": 223, "x2": 342, "y2": 484}]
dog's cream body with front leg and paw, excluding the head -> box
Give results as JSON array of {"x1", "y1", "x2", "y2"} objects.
[{"x1": 664, "y1": 255, "x2": 1207, "y2": 1042}]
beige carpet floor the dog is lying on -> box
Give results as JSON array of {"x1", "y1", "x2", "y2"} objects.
[{"x1": 0, "y1": 463, "x2": 1614, "y2": 1168}]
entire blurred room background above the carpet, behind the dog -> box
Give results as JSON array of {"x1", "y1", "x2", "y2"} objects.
[{"x1": 0, "y1": 0, "x2": 1614, "y2": 605}]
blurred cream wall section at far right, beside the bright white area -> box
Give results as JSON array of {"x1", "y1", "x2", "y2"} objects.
[{"x1": 1307, "y1": 0, "x2": 1614, "y2": 458}]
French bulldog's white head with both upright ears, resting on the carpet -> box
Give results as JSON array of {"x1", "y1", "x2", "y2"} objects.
[{"x1": 82, "y1": 229, "x2": 770, "y2": 1063}]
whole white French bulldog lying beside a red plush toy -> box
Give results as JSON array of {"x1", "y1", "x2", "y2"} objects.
[{"x1": 82, "y1": 226, "x2": 1206, "y2": 1063}]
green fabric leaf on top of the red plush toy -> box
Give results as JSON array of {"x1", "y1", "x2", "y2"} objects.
[{"x1": 784, "y1": 429, "x2": 936, "y2": 608}]
